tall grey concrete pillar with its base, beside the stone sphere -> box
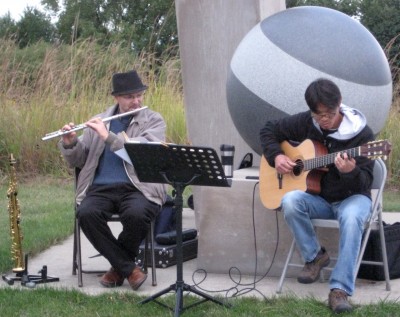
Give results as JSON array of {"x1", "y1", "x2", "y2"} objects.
[{"x1": 175, "y1": 0, "x2": 289, "y2": 273}]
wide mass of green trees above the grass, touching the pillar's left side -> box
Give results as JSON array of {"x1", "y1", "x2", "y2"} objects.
[{"x1": 42, "y1": 0, "x2": 178, "y2": 55}]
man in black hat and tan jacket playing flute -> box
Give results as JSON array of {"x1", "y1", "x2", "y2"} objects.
[{"x1": 58, "y1": 70, "x2": 166, "y2": 290}]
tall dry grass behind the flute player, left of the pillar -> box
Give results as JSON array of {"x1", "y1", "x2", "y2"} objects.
[{"x1": 0, "y1": 40, "x2": 186, "y2": 176}]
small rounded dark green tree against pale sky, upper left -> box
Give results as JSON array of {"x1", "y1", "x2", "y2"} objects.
[{"x1": 16, "y1": 6, "x2": 55, "y2": 48}]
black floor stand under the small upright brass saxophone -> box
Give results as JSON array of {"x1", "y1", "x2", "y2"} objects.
[{"x1": 2, "y1": 254, "x2": 60, "y2": 288}]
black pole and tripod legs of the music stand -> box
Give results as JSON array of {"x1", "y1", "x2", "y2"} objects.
[{"x1": 140, "y1": 179, "x2": 231, "y2": 317}]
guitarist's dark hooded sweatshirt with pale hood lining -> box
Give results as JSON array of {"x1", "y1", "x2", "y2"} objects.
[{"x1": 260, "y1": 104, "x2": 374, "y2": 203}]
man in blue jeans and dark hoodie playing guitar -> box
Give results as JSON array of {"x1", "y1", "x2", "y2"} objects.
[{"x1": 260, "y1": 78, "x2": 374, "y2": 313}]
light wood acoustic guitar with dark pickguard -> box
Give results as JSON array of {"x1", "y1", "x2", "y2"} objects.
[{"x1": 260, "y1": 140, "x2": 391, "y2": 209}]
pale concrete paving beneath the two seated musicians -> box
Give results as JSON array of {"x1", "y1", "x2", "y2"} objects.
[{"x1": 1, "y1": 209, "x2": 400, "y2": 304}]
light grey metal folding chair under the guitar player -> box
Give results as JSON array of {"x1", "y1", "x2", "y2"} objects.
[{"x1": 276, "y1": 158, "x2": 390, "y2": 294}]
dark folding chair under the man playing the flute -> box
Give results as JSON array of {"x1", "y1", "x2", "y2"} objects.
[{"x1": 72, "y1": 169, "x2": 157, "y2": 287}]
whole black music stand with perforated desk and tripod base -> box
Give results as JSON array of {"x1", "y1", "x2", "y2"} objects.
[{"x1": 125, "y1": 143, "x2": 230, "y2": 317}]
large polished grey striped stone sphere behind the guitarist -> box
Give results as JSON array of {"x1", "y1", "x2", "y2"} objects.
[{"x1": 226, "y1": 7, "x2": 392, "y2": 154}]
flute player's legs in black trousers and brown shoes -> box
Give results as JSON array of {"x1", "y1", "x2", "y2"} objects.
[{"x1": 78, "y1": 186, "x2": 159, "y2": 290}]
